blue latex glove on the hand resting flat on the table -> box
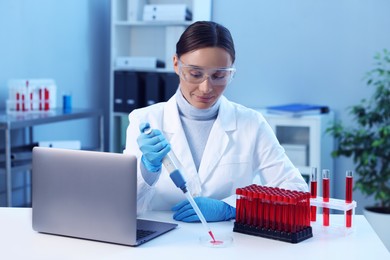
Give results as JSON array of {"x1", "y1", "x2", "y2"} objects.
[{"x1": 172, "y1": 197, "x2": 236, "y2": 222}]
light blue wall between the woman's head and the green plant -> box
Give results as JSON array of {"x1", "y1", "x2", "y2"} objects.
[{"x1": 213, "y1": 0, "x2": 390, "y2": 213}]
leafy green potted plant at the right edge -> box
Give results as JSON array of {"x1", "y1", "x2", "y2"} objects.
[{"x1": 327, "y1": 49, "x2": 390, "y2": 250}]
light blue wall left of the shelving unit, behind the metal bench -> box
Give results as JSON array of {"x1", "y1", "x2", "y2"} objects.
[{"x1": 0, "y1": 0, "x2": 110, "y2": 146}]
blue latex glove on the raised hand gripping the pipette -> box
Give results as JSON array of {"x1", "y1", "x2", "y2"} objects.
[{"x1": 137, "y1": 123, "x2": 171, "y2": 172}]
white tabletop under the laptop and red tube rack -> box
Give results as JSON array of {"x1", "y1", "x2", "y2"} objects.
[{"x1": 0, "y1": 208, "x2": 390, "y2": 260}]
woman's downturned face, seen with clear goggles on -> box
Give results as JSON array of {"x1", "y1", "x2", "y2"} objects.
[{"x1": 173, "y1": 47, "x2": 233, "y2": 109}]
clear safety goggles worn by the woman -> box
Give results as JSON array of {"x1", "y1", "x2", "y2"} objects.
[{"x1": 178, "y1": 59, "x2": 236, "y2": 86}]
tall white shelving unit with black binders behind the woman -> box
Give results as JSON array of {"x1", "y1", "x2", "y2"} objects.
[{"x1": 109, "y1": 0, "x2": 212, "y2": 152}]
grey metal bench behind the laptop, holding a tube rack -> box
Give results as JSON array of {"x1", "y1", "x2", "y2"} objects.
[{"x1": 0, "y1": 108, "x2": 104, "y2": 207}]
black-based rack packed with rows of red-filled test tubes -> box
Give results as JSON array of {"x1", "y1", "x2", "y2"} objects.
[{"x1": 233, "y1": 184, "x2": 313, "y2": 243}]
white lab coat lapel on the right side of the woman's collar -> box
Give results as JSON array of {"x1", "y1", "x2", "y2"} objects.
[{"x1": 199, "y1": 96, "x2": 237, "y2": 183}]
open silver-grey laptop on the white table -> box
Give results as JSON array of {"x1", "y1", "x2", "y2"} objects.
[{"x1": 32, "y1": 147, "x2": 177, "y2": 246}]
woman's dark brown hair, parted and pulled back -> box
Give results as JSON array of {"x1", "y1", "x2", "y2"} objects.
[{"x1": 176, "y1": 21, "x2": 236, "y2": 63}]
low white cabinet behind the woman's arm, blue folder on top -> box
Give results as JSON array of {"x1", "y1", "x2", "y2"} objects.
[{"x1": 260, "y1": 111, "x2": 335, "y2": 196}]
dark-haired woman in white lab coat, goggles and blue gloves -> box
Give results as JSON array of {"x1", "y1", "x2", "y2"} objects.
[{"x1": 124, "y1": 22, "x2": 308, "y2": 222}]
